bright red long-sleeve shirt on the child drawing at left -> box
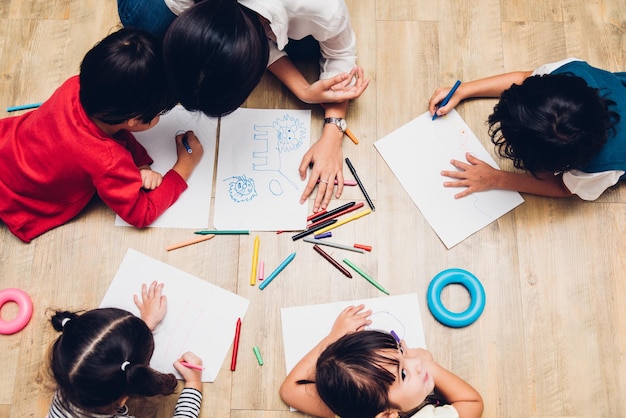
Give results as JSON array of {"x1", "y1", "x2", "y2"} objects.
[{"x1": 0, "y1": 76, "x2": 187, "y2": 242}]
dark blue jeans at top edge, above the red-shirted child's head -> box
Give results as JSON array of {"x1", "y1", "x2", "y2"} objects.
[{"x1": 117, "y1": 0, "x2": 176, "y2": 39}]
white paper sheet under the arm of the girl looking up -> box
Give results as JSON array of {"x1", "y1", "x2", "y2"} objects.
[{"x1": 280, "y1": 293, "x2": 426, "y2": 374}]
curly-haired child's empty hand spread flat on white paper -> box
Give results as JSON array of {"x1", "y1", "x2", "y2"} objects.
[{"x1": 441, "y1": 152, "x2": 500, "y2": 199}]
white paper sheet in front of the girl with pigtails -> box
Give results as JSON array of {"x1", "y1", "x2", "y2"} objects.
[{"x1": 100, "y1": 249, "x2": 250, "y2": 382}]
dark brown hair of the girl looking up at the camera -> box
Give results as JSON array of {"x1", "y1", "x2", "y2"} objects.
[{"x1": 298, "y1": 330, "x2": 399, "y2": 418}]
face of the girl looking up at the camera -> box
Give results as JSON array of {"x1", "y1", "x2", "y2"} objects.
[{"x1": 380, "y1": 341, "x2": 435, "y2": 412}]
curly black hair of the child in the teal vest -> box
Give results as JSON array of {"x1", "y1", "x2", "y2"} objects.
[{"x1": 488, "y1": 74, "x2": 619, "y2": 175}]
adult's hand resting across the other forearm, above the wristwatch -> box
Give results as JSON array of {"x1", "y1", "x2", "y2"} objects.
[{"x1": 298, "y1": 67, "x2": 370, "y2": 103}]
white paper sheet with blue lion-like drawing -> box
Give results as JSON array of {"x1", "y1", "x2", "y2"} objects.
[{"x1": 213, "y1": 108, "x2": 311, "y2": 231}]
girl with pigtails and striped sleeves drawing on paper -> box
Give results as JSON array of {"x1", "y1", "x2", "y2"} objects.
[{"x1": 48, "y1": 282, "x2": 202, "y2": 418}]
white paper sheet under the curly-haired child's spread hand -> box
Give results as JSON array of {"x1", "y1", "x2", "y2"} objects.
[{"x1": 374, "y1": 110, "x2": 524, "y2": 248}]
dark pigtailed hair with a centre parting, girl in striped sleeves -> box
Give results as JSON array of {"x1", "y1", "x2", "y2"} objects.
[{"x1": 50, "y1": 308, "x2": 177, "y2": 411}]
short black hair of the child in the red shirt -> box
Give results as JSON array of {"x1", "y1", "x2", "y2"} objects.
[{"x1": 80, "y1": 28, "x2": 176, "y2": 125}]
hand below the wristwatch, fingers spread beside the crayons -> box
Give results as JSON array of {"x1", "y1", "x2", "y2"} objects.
[{"x1": 299, "y1": 124, "x2": 343, "y2": 212}]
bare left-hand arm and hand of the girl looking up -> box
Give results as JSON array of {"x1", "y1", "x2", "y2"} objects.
[{"x1": 279, "y1": 305, "x2": 371, "y2": 418}]
